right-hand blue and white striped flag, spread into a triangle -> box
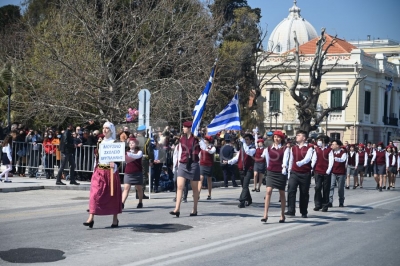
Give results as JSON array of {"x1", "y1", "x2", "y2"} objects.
[{"x1": 207, "y1": 93, "x2": 242, "y2": 136}]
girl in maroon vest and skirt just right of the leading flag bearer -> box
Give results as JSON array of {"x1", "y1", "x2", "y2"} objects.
[{"x1": 199, "y1": 136, "x2": 216, "y2": 200}]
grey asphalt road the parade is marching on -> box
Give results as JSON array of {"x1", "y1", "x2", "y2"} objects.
[{"x1": 0, "y1": 178, "x2": 400, "y2": 266}]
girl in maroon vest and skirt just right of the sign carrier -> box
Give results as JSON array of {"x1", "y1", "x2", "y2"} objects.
[{"x1": 122, "y1": 139, "x2": 143, "y2": 209}]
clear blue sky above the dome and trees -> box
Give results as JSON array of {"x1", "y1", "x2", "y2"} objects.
[{"x1": 0, "y1": 0, "x2": 400, "y2": 42}]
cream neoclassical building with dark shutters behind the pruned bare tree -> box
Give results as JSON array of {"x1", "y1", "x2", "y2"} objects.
[{"x1": 257, "y1": 1, "x2": 400, "y2": 144}]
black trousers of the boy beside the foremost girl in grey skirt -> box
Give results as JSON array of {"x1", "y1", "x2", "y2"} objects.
[{"x1": 288, "y1": 171, "x2": 311, "y2": 214}]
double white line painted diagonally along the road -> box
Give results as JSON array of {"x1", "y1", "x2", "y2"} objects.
[{"x1": 125, "y1": 196, "x2": 400, "y2": 266}]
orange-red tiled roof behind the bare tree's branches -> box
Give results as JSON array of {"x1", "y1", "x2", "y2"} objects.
[{"x1": 290, "y1": 34, "x2": 358, "y2": 54}]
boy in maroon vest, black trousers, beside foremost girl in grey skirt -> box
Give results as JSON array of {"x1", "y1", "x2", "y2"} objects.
[{"x1": 285, "y1": 130, "x2": 314, "y2": 218}]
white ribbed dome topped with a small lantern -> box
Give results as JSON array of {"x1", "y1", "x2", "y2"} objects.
[{"x1": 268, "y1": 0, "x2": 318, "y2": 53}]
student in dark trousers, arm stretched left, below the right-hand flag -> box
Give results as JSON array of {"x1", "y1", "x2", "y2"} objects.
[{"x1": 227, "y1": 134, "x2": 256, "y2": 208}]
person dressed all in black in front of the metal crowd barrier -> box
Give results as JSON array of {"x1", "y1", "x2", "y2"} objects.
[{"x1": 56, "y1": 125, "x2": 79, "y2": 185}]
